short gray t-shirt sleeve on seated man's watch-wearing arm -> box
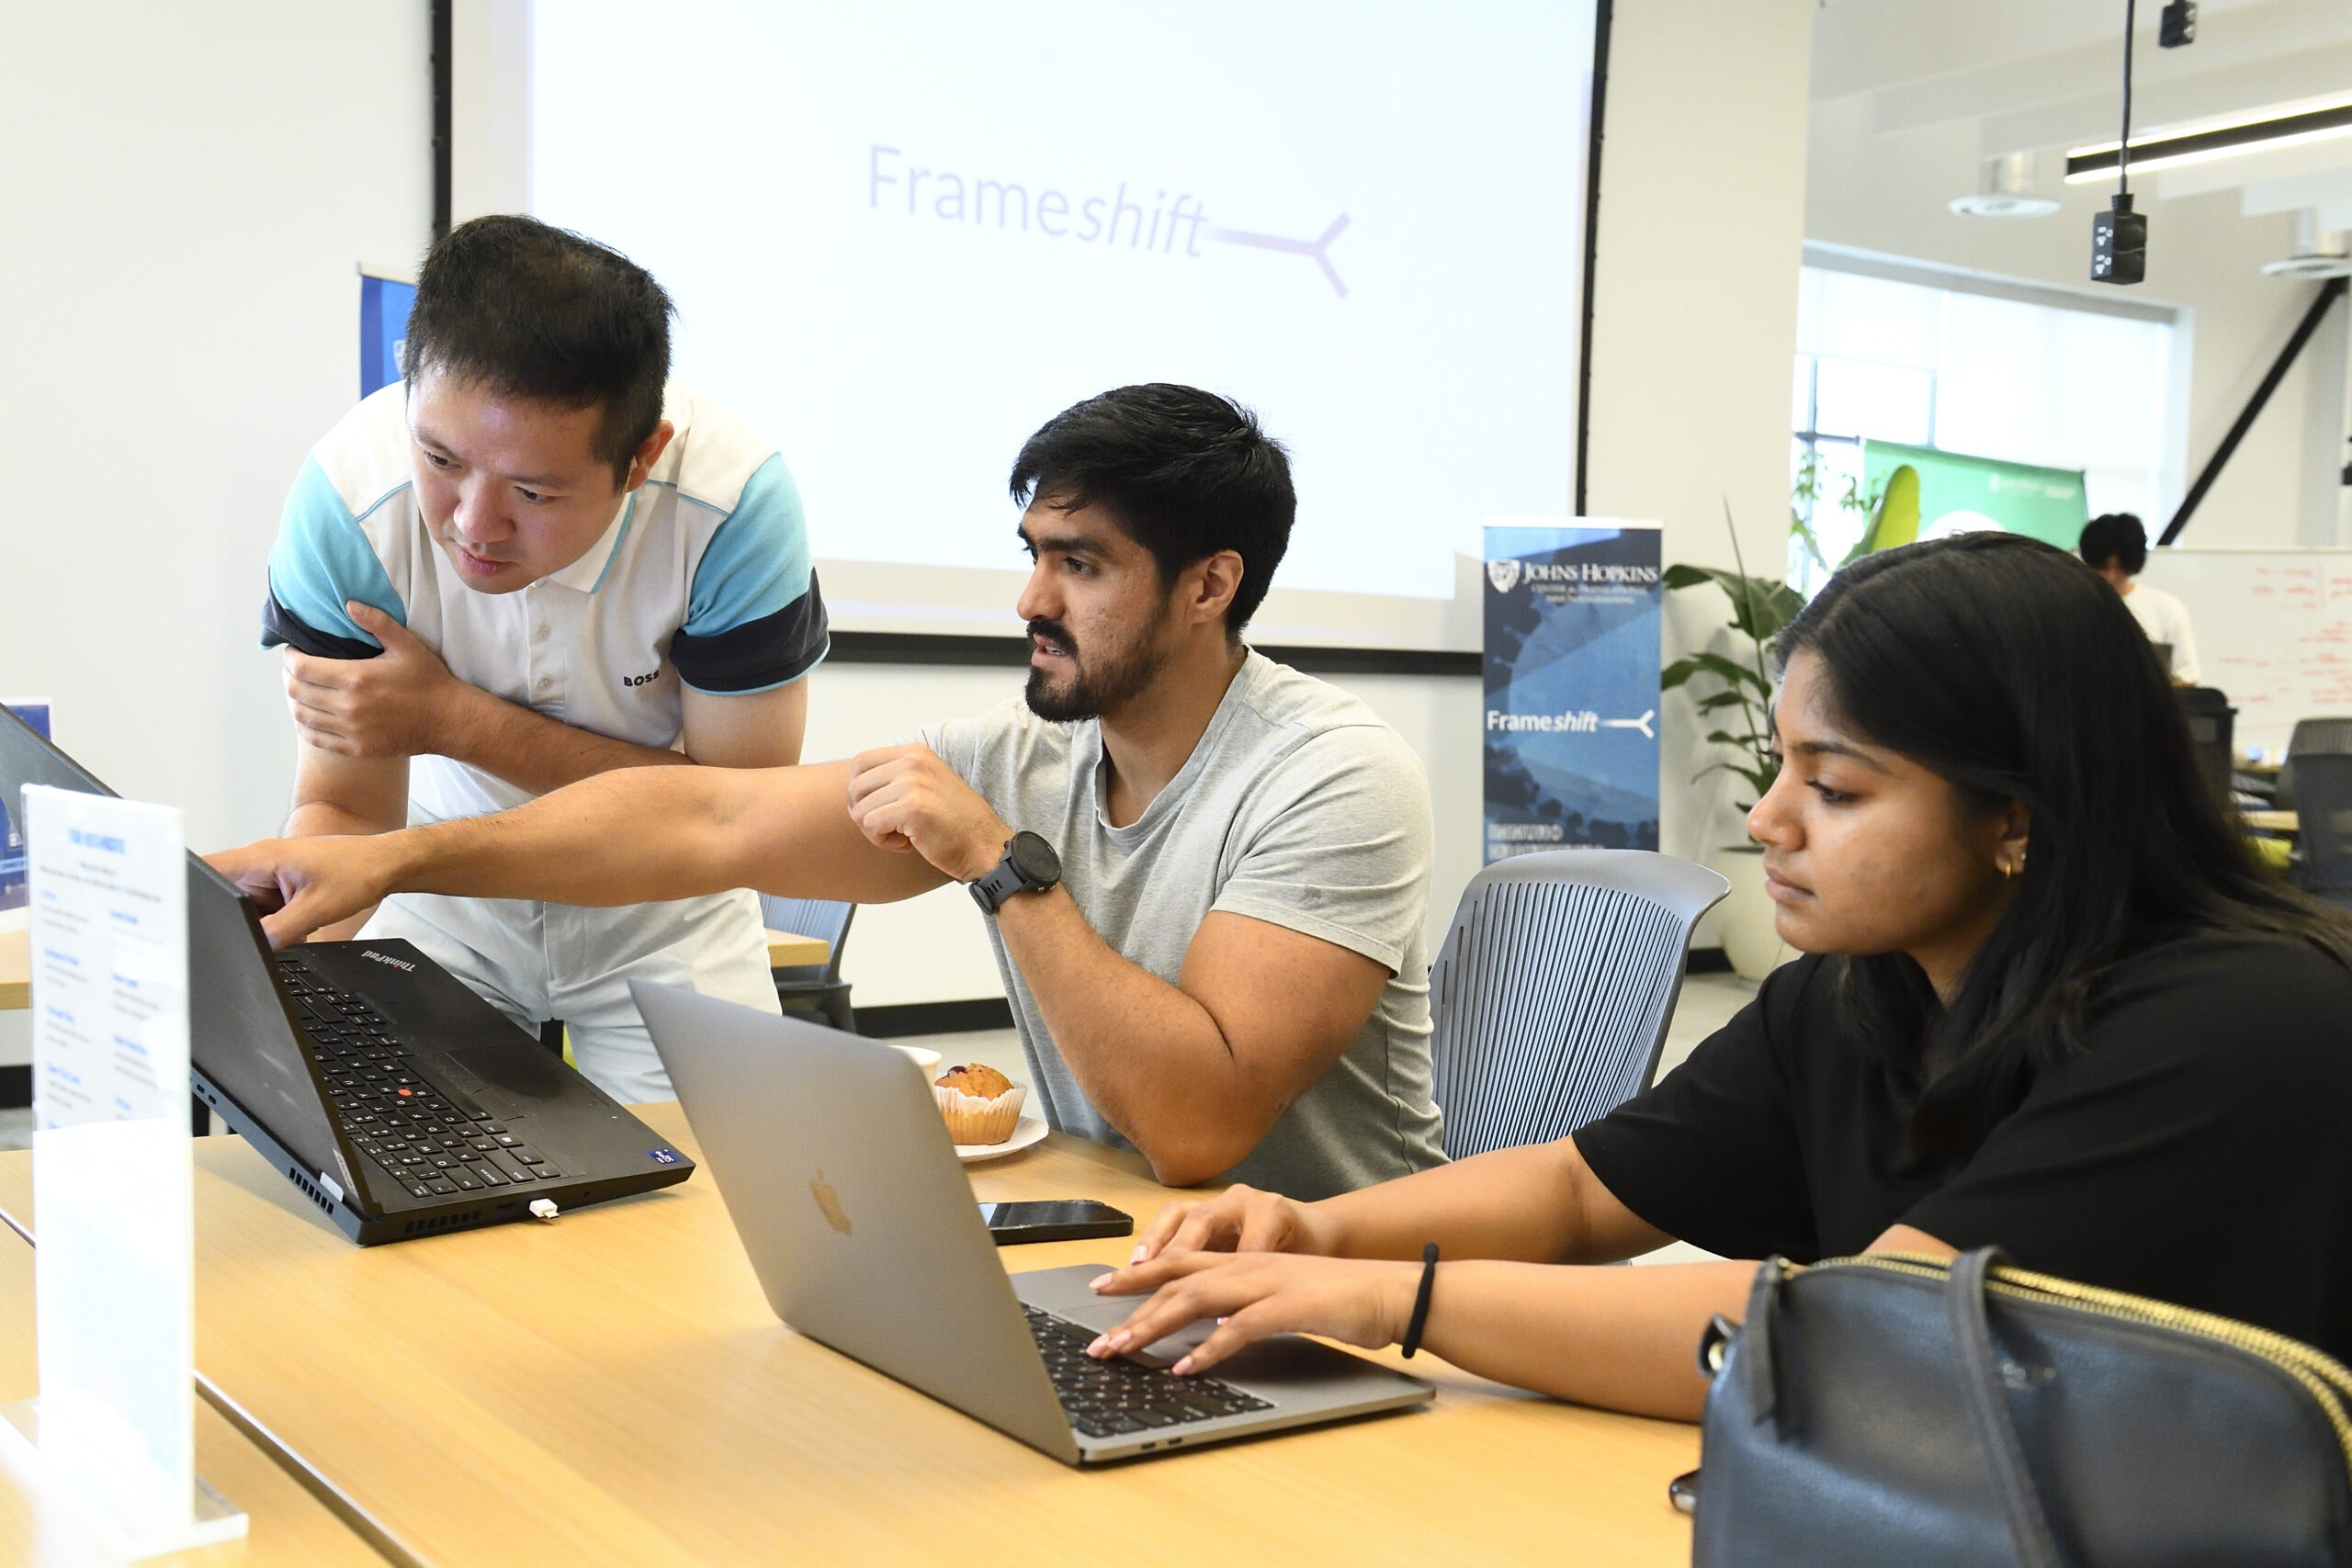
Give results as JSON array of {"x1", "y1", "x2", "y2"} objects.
[{"x1": 1211, "y1": 724, "x2": 1435, "y2": 974}]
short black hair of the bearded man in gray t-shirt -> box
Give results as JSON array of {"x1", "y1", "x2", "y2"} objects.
[{"x1": 1012, "y1": 381, "x2": 1298, "y2": 637}]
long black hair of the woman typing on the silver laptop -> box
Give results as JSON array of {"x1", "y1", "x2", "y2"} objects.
[{"x1": 1778, "y1": 531, "x2": 2352, "y2": 1161}]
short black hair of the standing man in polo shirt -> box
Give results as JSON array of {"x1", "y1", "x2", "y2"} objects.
[{"x1": 400, "y1": 214, "x2": 671, "y2": 484}]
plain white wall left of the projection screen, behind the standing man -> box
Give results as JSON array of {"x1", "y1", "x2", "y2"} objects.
[{"x1": 0, "y1": 0, "x2": 433, "y2": 1063}]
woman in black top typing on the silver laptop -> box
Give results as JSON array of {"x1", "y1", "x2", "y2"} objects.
[{"x1": 1077, "y1": 534, "x2": 2352, "y2": 1417}]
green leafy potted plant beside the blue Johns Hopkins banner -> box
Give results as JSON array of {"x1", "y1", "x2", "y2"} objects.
[{"x1": 1658, "y1": 510, "x2": 1804, "y2": 980}]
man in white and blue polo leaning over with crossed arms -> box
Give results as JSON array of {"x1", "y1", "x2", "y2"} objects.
[{"x1": 264, "y1": 216, "x2": 826, "y2": 1102}]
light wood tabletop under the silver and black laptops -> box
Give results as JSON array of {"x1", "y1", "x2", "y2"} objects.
[{"x1": 0, "y1": 1105, "x2": 1698, "y2": 1568}]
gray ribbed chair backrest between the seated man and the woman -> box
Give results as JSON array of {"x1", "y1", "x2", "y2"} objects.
[{"x1": 1430, "y1": 849, "x2": 1731, "y2": 1159}]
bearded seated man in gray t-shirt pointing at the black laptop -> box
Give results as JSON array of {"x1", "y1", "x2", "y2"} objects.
[{"x1": 214, "y1": 386, "x2": 1444, "y2": 1199}]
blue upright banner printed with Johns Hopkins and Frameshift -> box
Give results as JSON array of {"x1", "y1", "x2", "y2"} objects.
[{"x1": 1487, "y1": 520, "x2": 1663, "y2": 863}]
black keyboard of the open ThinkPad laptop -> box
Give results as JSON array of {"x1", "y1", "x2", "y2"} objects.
[{"x1": 277, "y1": 959, "x2": 564, "y2": 1199}]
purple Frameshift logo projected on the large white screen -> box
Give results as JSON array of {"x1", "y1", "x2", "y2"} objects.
[{"x1": 865, "y1": 143, "x2": 1348, "y2": 299}]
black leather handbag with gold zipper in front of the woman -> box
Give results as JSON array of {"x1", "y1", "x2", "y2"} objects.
[{"x1": 1691, "y1": 1246, "x2": 2352, "y2": 1568}]
